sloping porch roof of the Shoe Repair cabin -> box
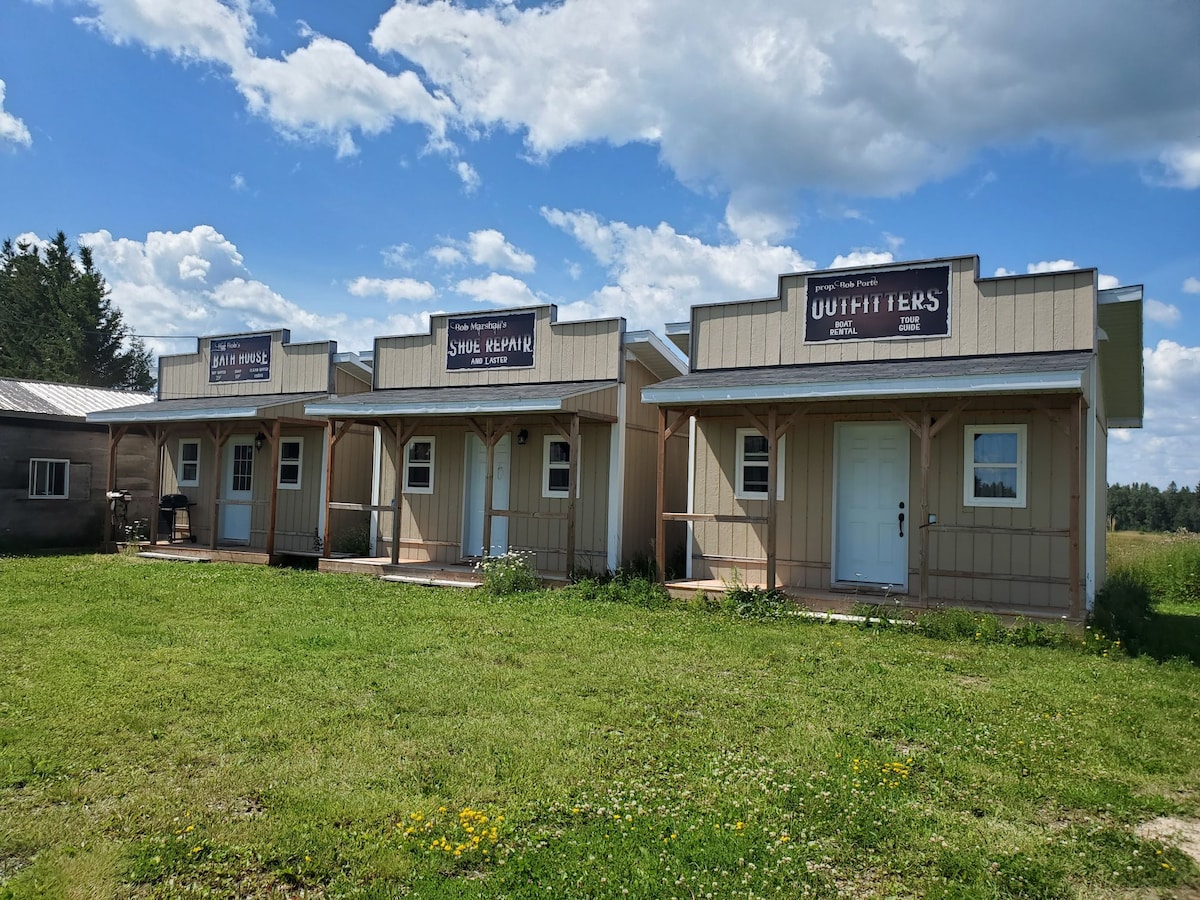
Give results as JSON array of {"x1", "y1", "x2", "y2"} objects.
[{"x1": 305, "y1": 382, "x2": 618, "y2": 419}]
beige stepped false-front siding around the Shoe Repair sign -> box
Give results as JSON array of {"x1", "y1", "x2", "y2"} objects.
[{"x1": 374, "y1": 306, "x2": 624, "y2": 390}]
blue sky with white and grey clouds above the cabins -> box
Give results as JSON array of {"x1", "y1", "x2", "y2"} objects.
[{"x1": 0, "y1": 0, "x2": 1200, "y2": 487}]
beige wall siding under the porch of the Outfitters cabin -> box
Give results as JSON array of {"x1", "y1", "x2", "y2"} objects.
[{"x1": 692, "y1": 397, "x2": 1070, "y2": 613}]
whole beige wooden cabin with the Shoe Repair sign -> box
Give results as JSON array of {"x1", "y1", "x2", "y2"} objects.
[{"x1": 305, "y1": 306, "x2": 686, "y2": 574}]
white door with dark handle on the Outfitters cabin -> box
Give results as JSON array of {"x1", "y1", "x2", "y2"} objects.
[{"x1": 833, "y1": 422, "x2": 913, "y2": 590}]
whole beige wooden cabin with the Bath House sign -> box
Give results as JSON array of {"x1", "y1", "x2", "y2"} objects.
[{"x1": 88, "y1": 330, "x2": 371, "y2": 563}]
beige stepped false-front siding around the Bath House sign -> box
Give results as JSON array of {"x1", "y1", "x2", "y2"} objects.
[{"x1": 158, "y1": 331, "x2": 335, "y2": 400}]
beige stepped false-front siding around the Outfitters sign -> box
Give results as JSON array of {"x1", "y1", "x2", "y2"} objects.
[{"x1": 692, "y1": 257, "x2": 1096, "y2": 371}]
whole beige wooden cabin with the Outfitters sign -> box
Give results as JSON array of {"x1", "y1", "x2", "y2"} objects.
[{"x1": 642, "y1": 257, "x2": 1142, "y2": 619}]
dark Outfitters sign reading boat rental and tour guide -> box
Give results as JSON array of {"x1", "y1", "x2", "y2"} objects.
[{"x1": 804, "y1": 265, "x2": 950, "y2": 343}]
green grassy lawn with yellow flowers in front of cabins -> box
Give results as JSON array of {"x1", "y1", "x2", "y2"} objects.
[{"x1": 0, "y1": 547, "x2": 1200, "y2": 900}]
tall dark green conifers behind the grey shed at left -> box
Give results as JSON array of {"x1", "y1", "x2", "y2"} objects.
[{"x1": 0, "y1": 232, "x2": 155, "y2": 391}]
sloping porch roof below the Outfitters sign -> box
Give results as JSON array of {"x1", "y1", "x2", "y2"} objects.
[{"x1": 642, "y1": 350, "x2": 1093, "y2": 407}]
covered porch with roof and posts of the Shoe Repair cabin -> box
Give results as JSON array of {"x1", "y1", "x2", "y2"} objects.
[{"x1": 307, "y1": 382, "x2": 618, "y2": 581}]
